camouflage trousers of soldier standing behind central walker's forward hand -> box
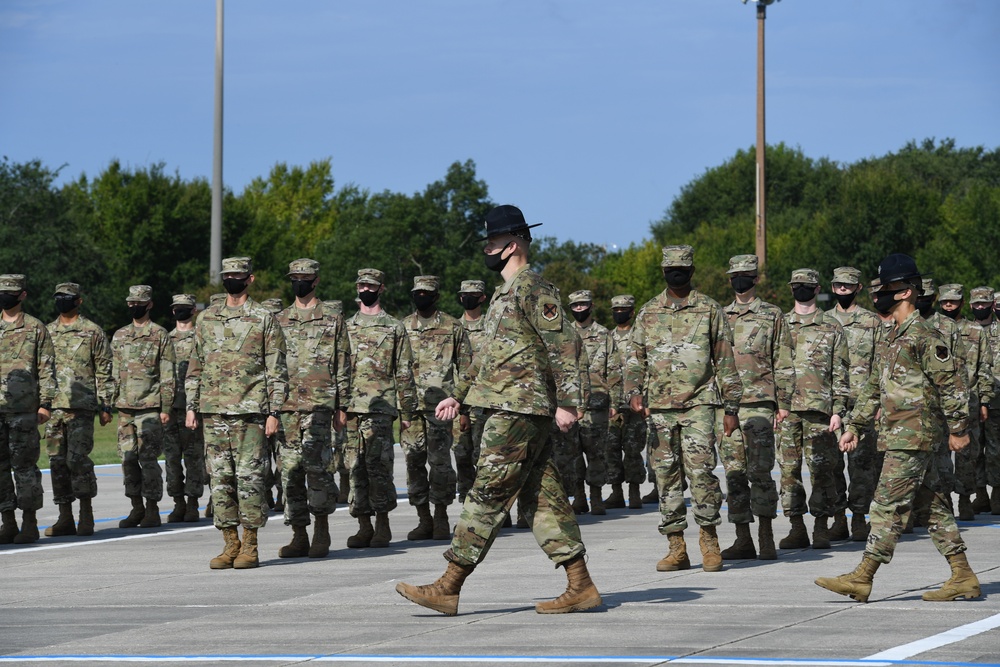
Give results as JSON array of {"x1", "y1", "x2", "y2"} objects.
[{"x1": 399, "y1": 412, "x2": 457, "y2": 505}]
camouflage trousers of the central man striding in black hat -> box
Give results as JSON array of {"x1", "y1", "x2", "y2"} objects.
[{"x1": 445, "y1": 410, "x2": 586, "y2": 565}]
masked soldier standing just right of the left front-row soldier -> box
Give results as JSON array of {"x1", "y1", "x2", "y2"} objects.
[{"x1": 277, "y1": 258, "x2": 351, "y2": 558}]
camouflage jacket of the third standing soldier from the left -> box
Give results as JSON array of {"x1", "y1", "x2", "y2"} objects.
[{"x1": 111, "y1": 322, "x2": 176, "y2": 413}]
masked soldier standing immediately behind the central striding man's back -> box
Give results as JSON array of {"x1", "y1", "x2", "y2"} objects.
[{"x1": 553, "y1": 290, "x2": 622, "y2": 514}]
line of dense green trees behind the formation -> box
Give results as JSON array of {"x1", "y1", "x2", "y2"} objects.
[{"x1": 0, "y1": 139, "x2": 1000, "y2": 330}]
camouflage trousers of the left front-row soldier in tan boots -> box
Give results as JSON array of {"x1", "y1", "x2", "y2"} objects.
[{"x1": 202, "y1": 414, "x2": 269, "y2": 530}]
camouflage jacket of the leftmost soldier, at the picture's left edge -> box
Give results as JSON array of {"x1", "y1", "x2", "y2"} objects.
[{"x1": 0, "y1": 312, "x2": 58, "y2": 413}]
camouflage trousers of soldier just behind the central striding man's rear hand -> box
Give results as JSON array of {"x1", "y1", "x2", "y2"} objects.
[{"x1": 552, "y1": 410, "x2": 608, "y2": 491}]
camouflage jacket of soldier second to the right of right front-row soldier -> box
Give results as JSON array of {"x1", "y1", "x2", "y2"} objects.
[{"x1": 785, "y1": 309, "x2": 851, "y2": 415}]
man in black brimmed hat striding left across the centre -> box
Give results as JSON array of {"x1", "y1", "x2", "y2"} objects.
[{"x1": 396, "y1": 205, "x2": 602, "y2": 615}]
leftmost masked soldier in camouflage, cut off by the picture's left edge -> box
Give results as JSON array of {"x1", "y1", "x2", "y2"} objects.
[{"x1": 0, "y1": 273, "x2": 58, "y2": 544}]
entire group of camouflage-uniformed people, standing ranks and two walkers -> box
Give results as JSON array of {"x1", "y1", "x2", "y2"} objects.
[{"x1": 0, "y1": 205, "x2": 984, "y2": 615}]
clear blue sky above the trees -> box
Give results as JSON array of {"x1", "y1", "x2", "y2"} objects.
[{"x1": 0, "y1": 0, "x2": 1000, "y2": 252}]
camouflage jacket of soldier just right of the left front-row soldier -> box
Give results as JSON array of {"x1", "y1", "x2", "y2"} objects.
[{"x1": 276, "y1": 302, "x2": 351, "y2": 412}]
